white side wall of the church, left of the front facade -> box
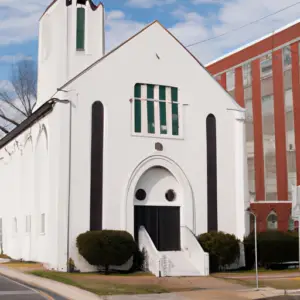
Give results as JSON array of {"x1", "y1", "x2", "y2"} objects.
[{"x1": 0, "y1": 105, "x2": 68, "y2": 270}]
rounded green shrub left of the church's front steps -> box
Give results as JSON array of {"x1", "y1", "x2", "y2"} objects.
[{"x1": 77, "y1": 230, "x2": 136, "y2": 274}]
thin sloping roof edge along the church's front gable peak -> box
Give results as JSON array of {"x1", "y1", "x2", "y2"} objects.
[{"x1": 58, "y1": 20, "x2": 212, "y2": 90}]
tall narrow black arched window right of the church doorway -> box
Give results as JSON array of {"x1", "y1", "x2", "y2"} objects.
[{"x1": 206, "y1": 114, "x2": 218, "y2": 232}]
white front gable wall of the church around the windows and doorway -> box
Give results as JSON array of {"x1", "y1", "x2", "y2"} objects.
[{"x1": 59, "y1": 23, "x2": 244, "y2": 266}]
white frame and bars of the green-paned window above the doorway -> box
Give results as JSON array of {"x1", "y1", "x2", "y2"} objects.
[{"x1": 130, "y1": 91, "x2": 186, "y2": 140}]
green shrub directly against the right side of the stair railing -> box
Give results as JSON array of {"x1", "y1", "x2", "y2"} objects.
[{"x1": 197, "y1": 231, "x2": 240, "y2": 272}]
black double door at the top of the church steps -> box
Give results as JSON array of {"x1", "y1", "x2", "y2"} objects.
[{"x1": 134, "y1": 206, "x2": 180, "y2": 251}]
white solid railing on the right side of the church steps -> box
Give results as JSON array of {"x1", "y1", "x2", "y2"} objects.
[{"x1": 180, "y1": 226, "x2": 209, "y2": 276}]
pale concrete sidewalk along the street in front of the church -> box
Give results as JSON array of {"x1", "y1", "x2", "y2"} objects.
[{"x1": 0, "y1": 265, "x2": 295, "y2": 300}]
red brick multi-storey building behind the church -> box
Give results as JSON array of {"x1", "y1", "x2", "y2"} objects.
[{"x1": 206, "y1": 21, "x2": 300, "y2": 231}]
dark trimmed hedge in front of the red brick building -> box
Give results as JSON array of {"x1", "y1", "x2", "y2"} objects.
[{"x1": 244, "y1": 231, "x2": 299, "y2": 269}]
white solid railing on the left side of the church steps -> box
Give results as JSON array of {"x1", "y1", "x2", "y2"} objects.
[{"x1": 139, "y1": 226, "x2": 161, "y2": 277}]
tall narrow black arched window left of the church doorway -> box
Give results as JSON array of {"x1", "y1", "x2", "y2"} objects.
[{"x1": 90, "y1": 101, "x2": 104, "y2": 230}]
